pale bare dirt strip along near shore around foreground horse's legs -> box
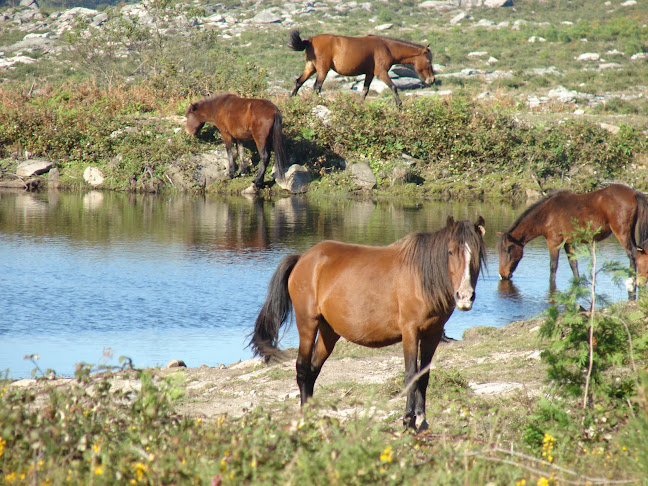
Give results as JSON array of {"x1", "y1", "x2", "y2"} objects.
[{"x1": 11, "y1": 321, "x2": 545, "y2": 420}]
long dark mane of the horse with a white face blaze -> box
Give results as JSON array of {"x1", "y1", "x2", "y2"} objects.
[{"x1": 396, "y1": 221, "x2": 486, "y2": 312}]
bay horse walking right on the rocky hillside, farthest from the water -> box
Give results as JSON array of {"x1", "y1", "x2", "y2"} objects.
[{"x1": 288, "y1": 30, "x2": 434, "y2": 109}]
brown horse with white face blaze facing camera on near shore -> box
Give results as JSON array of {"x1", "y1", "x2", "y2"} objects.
[{"x1": 250, "y1": 216, "x2": 486, "y2": 428}]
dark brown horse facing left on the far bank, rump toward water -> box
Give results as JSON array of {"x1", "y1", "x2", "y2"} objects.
[{"x1": 185, "y1": 94, "x2": 288, "y2": 187}]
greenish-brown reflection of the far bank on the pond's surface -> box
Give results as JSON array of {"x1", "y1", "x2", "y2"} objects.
[{"x1": 0, "y1": 191, "x2": 515, "y2": 250}]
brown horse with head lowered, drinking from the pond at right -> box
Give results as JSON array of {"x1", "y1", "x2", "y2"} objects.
[{"x1": 497, "y1": 184, "x2": 648, "y2": 290}]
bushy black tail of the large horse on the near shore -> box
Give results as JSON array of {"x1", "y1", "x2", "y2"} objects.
[{"x1": 249, "y1": 255, "x2": 300, "y2": 362}]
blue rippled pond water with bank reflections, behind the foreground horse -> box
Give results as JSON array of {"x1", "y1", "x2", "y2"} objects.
[{"x1": 0, "y1": 191, "x2": 627, "y2": 378}]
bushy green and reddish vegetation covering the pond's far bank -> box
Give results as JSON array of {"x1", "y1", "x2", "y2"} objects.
[{"x1": 0, "y1": 83, "x2": 648, "y2": 198}]
